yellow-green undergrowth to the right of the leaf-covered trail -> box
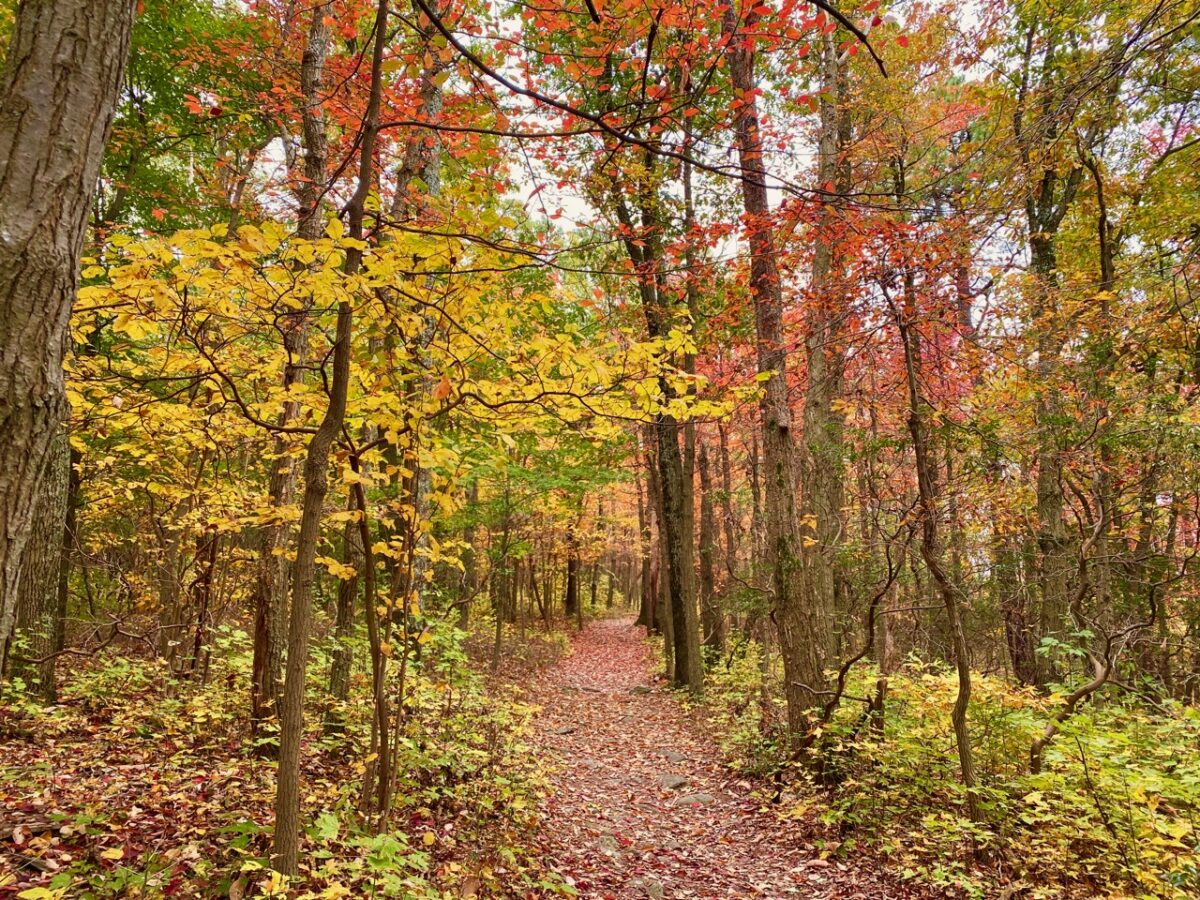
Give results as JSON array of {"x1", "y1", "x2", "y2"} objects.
[{"x1": 706, "y1": 647, "x2": 1200, "y2": 899}]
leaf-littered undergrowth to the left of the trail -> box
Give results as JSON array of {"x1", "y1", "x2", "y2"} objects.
[{"x1": 0, "y1": 625, "x2": 565, "y2": 900}]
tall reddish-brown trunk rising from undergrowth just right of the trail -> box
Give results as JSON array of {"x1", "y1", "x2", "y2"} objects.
[{"x1": 725, "y1": 8, "x2": 830, "y2": 736}]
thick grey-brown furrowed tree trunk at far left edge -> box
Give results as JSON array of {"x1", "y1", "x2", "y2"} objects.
[{"x1": 0, "y1": 0, "x2": 134, "y2": 672}]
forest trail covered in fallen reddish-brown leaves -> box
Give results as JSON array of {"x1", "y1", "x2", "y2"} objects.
[{"x1": 534, "y1": 619, "x2": 911, "y2": 900}]
